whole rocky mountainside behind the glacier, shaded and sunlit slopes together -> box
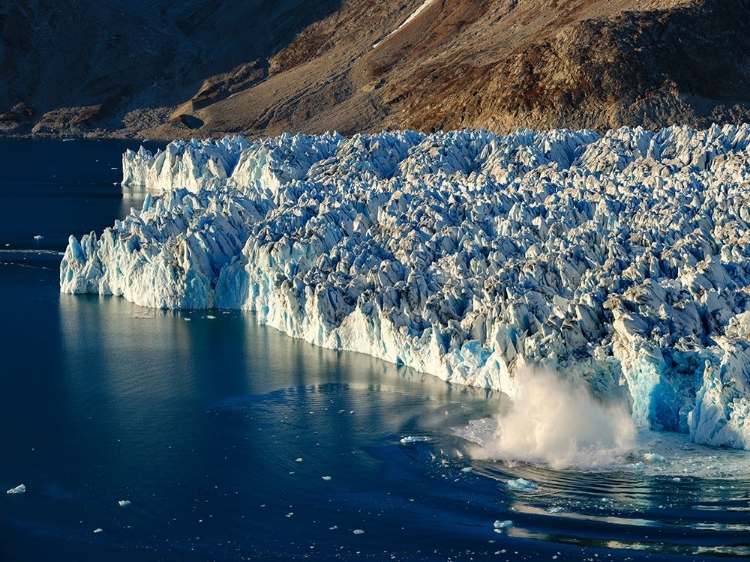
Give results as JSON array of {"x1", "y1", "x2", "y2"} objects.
[{"x1": 0, "y1": 0, "x2": 750, "y2": 138}]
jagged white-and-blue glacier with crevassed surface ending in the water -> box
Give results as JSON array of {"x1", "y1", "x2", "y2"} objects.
[{"x1": 60, "y1": 125, "x2": 750, "y2": 449}]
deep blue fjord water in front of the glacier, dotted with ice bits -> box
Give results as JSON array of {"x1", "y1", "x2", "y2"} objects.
[{"x1": 0, "y1": 141, "x2": 750, "y2": 561}]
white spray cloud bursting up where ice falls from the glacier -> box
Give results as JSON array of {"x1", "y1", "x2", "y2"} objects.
[{"x1": 471, "y1": 369, "x2": 636, "y2": 468}]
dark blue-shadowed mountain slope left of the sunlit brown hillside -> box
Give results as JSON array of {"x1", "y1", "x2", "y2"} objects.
[{"x1": 0, "y1": 0, "x2": 340, "y2": 133}]
